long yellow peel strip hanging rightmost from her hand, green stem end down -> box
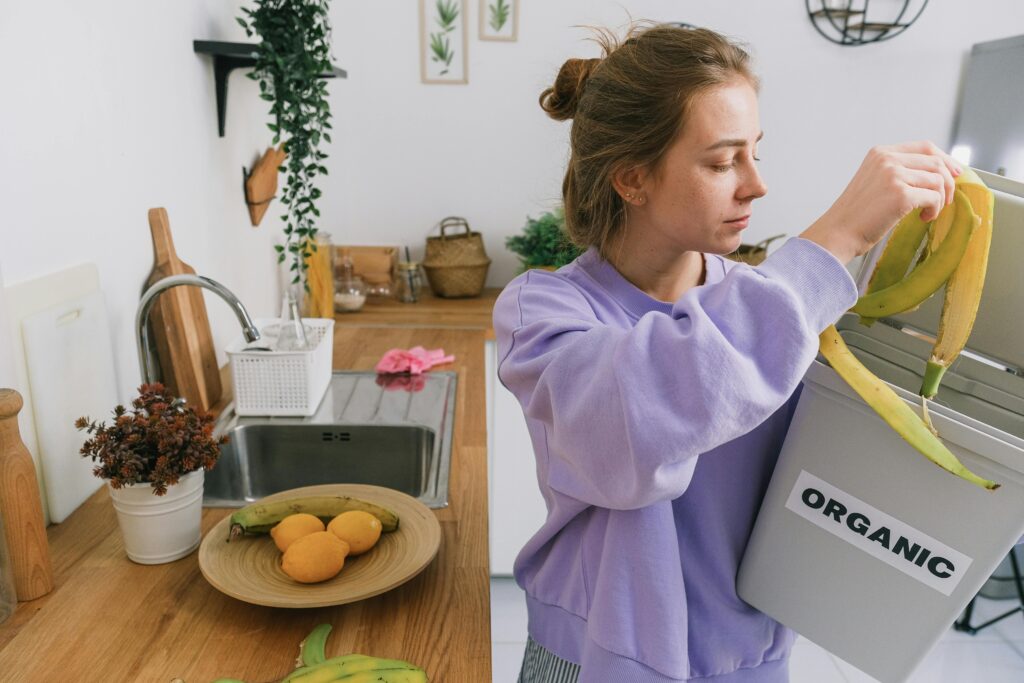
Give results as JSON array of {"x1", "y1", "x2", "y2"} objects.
[{"x1": 921, "y1": 168, "x2": 995, "y2": 398}]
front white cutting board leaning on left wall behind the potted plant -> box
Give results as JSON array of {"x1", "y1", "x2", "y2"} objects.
[{"x1": 22, "y1": 291, "x2": 118, "y2": 522}]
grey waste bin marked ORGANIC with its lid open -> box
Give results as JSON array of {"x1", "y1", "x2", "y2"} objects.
[{"x1": 737, "y1": 173, "x2": 1024, "y2": 683}]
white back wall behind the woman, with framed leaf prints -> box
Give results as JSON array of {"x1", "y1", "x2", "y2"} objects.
[{"x1": 326, "y1": 0, "x2": 1024, "y2": 285}]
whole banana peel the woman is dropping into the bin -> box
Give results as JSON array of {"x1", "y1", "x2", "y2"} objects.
[{"x1": 819, "y1": 169, "x2": 998, "y2": 489}]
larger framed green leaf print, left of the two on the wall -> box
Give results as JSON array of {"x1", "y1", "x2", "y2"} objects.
[{"x1": 420, "y1": 0, "x2": 469, "y2": 84}]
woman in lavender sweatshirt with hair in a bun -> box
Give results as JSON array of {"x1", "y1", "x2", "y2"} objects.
[{"x1": 495, "y1": 22, "x2": 959, "y2": 683}]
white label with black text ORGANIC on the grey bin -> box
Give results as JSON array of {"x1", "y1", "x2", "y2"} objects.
[{"x1": 785, "y1": 470, "x2": 973, "y2": 595}]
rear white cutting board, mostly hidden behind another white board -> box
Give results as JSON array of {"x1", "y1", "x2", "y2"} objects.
[{"x1": 3, "y1": 263, "x2": 99, "y2": 523}]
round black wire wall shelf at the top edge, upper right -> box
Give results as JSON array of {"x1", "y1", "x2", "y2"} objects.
[{"x1": 804, "y1": 0, "x2": 928, "y2": 47}]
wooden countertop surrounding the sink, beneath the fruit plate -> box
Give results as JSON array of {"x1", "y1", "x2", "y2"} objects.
[{"x1": 0, "y1": 290, "x2": 498, "y2": 683}]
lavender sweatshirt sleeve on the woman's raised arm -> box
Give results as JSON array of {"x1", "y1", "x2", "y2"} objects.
[{"x1": 494, "y1": 238, "x2": 857, "y2": 509}]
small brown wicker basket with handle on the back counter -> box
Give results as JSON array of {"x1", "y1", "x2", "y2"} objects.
[{"x1": 423, "y1": 216, "x2": 490, "y2": 299}]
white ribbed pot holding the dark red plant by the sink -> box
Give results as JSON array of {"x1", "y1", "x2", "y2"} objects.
[{"x1": 106, "y1": 469, "x2": 204, "y2": 564}]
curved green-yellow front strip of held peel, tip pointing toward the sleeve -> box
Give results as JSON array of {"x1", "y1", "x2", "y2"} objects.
[{"x1": 851, "y1": 190, "x2": 979, "y2": 318}]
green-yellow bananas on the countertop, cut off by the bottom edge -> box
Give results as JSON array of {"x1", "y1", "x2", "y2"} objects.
[{"x1": 214, "y1": 624, "x2": 429, "y2": 683}]
